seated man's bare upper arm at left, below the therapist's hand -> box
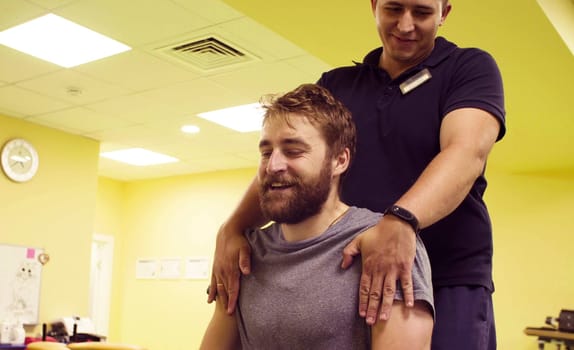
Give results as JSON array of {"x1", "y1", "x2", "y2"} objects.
[{"x1": 200, "y1": 294, "x2": 241, "y2": 350}]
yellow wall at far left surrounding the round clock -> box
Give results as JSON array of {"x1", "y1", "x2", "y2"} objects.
[{"x1": 0, "y1": 116, "x2": 99, "y2": 334}]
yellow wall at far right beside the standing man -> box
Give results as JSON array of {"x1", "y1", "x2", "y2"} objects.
[{"x1": 486, "y1": 171, "x2": 574, "y2": 350}]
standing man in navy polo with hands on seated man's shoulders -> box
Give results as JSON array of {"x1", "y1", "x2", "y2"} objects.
[{"x1": 210, "y1": 0, "x2": 505, "y2": 350}]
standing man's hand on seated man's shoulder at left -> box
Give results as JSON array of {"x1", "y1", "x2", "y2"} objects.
[{"x1": 207, "y1": 225, "x2": 251, "y2": 314}]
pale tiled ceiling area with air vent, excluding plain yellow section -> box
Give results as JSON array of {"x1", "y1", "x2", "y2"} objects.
[{"x1": 0, "y1": 0, "x2": 329, "y2": 180}]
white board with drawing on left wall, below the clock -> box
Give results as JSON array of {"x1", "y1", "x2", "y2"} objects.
[{"x1": 0, "y1": 244, "x2": 42, "y2": 325}]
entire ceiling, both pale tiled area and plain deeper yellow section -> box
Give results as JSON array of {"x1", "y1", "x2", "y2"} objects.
[{"x1": 0, "y1": 0, "x2": 574, "y2": 181}]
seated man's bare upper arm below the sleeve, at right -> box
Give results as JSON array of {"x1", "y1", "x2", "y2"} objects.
[{"x1": 371, "y1": 301, "x2": 433, "y2": 350}]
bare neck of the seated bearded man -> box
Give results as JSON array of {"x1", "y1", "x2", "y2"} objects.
[{"x1": 281, "y1": 198, "x2": 349, "y2": 242}]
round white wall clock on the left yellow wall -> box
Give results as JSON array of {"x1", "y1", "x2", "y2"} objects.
[{"x1": 1, "y1": 138, "x2": 39, "y2": 182}]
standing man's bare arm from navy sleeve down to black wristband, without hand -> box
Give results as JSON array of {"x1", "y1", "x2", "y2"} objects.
[{"x1": 397, "y1": 108, "x2": 500, "y2": 227}]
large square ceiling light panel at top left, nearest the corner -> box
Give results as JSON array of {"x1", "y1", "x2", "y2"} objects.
[{"x1": 0, "y1": 13, "x2": 131, "y2": 68}]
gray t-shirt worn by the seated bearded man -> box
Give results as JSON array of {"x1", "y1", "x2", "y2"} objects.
[{"x1": 236, "y1": 207, "x2": 433, "y2": 350}]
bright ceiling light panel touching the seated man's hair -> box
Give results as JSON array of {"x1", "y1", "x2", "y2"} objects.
[{"x1": 197, "y1": 103, "x2": 265, "y2": 132}]
